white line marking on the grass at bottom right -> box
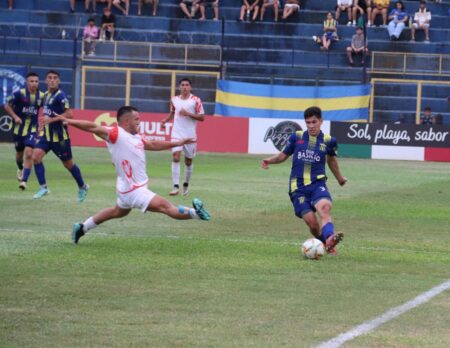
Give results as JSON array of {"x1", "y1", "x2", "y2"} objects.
[{"x1": 317, "y1": 279, "x2": 450, "y2": 348}]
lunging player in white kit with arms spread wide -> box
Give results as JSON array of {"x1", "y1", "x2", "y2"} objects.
[{"x1": 64, "y1": 106, "x2": 211, "y2": 244}]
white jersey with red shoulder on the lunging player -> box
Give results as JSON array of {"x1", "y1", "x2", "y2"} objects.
[{"x1": 106, "y1": 127, "x2": 148, "y2": 194}]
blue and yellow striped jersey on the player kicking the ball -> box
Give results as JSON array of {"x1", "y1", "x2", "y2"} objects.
[{"x1": 282, "y1": 131, "x2": 337, "y2": 193}]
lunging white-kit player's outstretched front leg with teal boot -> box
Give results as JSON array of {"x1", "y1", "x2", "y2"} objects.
[{"x1": 147, "y1": 195, "x2": 211, "y2": 220}]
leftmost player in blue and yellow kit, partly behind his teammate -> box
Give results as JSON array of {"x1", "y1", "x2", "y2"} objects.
[{"x1": 5, "y1": 72, "x2": 44, "y2": 190}]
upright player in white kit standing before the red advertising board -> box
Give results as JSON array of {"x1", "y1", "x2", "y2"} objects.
[{"x1": 161, "y1": 79, "x2": 205, "y2": 196}]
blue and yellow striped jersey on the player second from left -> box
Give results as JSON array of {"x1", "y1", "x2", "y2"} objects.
[{"x1": 40, "y1": 89, "x2": 70, "y2": 142}]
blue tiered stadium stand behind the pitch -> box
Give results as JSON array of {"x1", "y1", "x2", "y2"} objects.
[{"x1": 0, "y1": 0, "x2": 450, "y2": 123}]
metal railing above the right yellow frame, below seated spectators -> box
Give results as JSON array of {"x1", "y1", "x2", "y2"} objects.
[{"x1": 368, "y1": 51, "x2": 450, "y2": 76}]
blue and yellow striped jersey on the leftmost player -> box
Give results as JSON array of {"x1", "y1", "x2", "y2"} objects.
[{"x1": 7, "y1": 88, "x2": 44, "y2": 137}]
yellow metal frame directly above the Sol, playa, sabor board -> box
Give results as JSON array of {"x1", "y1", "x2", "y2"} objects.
[{"x1": 369, "y1": 78, "x2": 450, "y2": 124}]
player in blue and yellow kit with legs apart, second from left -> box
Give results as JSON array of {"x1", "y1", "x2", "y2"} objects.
[{"x1": 33, "y1": 70, "x2": 89, "y2": 202}]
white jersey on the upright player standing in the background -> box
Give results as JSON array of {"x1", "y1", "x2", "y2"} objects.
[{"x1": 170, "y1": 94, "x2": 205, "y2": 139}]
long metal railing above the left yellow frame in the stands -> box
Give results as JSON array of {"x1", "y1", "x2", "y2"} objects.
[{"x1": 81, "y1": 41, "x2": 222, "y2": 68}]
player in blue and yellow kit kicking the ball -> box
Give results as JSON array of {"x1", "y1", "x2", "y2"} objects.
[{"x1": 261, "y1": 106, "x2": 347, "y2": 254}]
